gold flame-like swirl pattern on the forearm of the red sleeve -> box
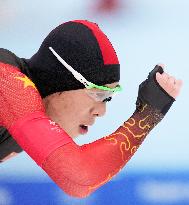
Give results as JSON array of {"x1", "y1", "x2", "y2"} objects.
[{"x1": 89, "y1": 104, "x2": 159, "y2": 192}]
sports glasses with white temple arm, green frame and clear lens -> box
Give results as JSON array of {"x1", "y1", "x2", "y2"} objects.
[{"x1": 49, "y1": 47, "x2": 122, "y2": 102}]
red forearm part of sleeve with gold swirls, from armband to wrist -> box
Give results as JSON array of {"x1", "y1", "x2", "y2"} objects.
[{"x1": 42, "y1": 105, "x2": 162, "y2": 197}]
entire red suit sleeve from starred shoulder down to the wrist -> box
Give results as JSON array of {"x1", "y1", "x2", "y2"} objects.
[{"x1": 0, "y1": 64, "x2": 163, "y2": 197}]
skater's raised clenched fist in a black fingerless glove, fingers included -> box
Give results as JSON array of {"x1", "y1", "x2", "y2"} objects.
[{"x1": 136, "y1": 64, "x2": 182, "y2": 115}]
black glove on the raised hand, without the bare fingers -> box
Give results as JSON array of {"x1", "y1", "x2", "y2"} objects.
[{"x1": 136, "y1": 65, "x2": 175, "y2": 115}]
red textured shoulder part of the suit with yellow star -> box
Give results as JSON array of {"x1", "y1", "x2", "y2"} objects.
[{"x1": 0, "y1": 62, "x2": 44, "y2": 129}]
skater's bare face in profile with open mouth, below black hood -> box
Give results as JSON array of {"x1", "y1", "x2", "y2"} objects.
[{"x1": 43, "y1": 82, "x2": 118, "y2": 138}]
